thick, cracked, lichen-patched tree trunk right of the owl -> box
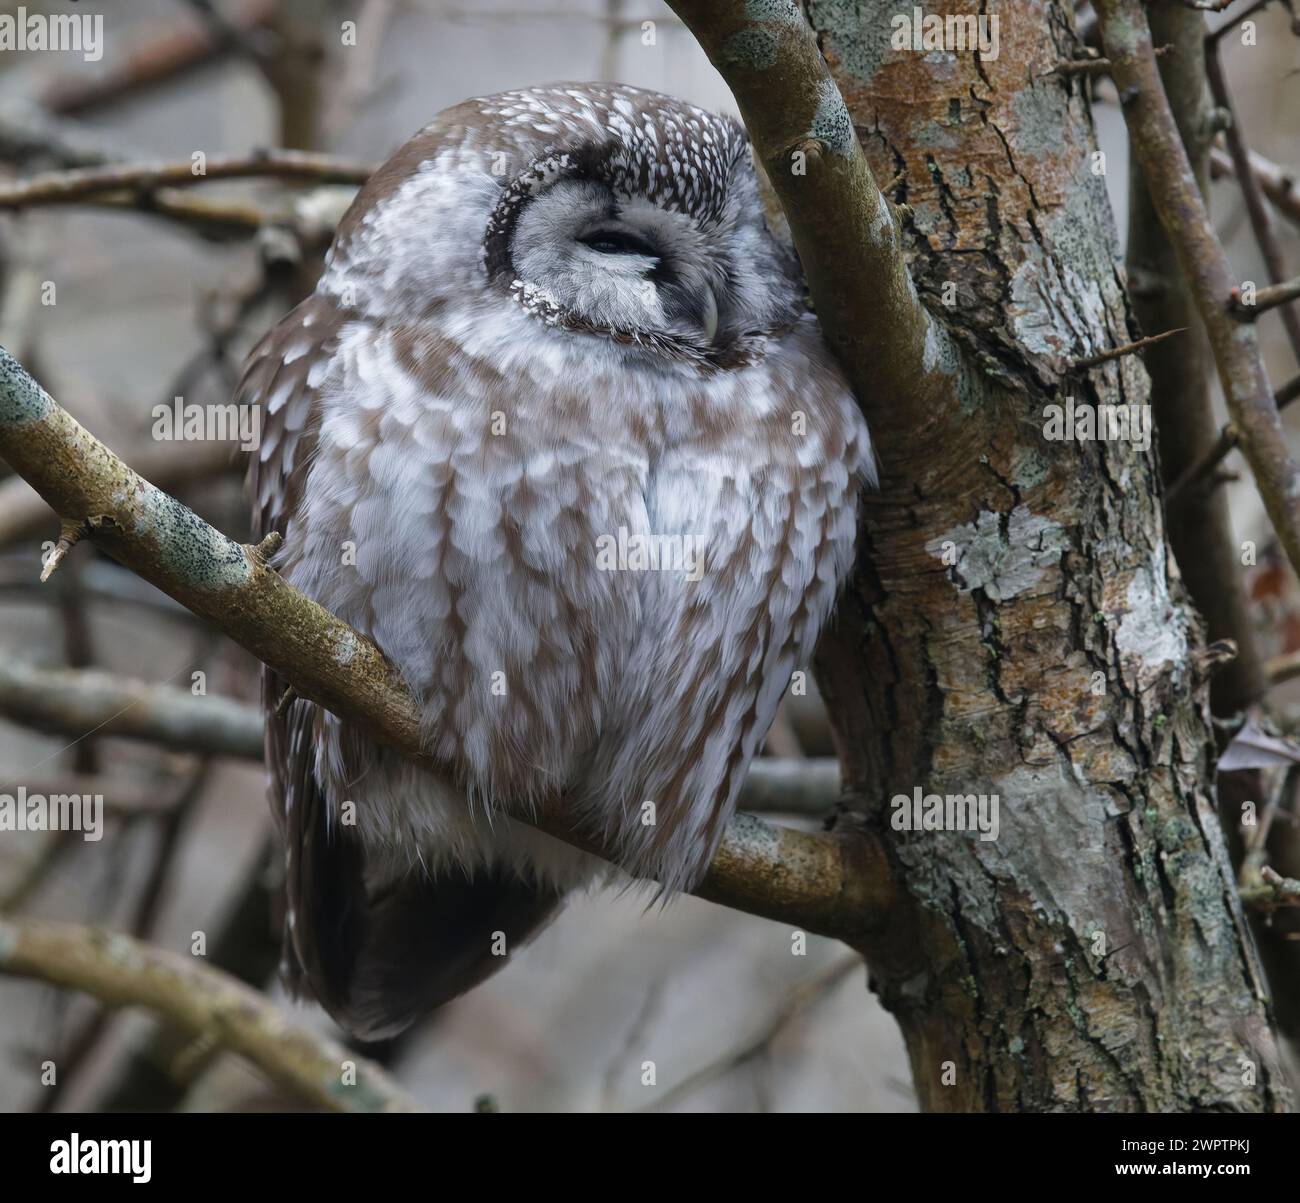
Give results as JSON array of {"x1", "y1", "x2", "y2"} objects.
[{"x1": 675, "y1": 0, "x2": 1290, "y2": 1111}]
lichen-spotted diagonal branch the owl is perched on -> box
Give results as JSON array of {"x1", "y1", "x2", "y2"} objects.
[{"x1": 0, "y1": 349, "x2": 893, "y2": 945}]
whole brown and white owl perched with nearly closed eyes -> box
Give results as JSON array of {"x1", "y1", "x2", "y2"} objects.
[{"x1": 239, "y1": 85, "x2": 874, "y2": 1039}]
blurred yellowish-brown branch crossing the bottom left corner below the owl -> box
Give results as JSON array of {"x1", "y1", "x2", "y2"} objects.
[{"x1": 0, "y1": 919, "x2": 424, "y2": 1112}]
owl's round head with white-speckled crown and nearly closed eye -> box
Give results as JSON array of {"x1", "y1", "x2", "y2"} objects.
[{"x1": 322, "y1": 85, "x2": 801, "y2": 368}]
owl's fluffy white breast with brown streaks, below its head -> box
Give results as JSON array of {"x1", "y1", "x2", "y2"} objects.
[{"x1": 247, "y1": 299, "x2": 871, "y2": 888}]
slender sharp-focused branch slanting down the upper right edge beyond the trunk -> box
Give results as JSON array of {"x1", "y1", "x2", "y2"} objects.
[{"x1": 1097, "y1": 0, "x2": 1300, "y2": 582}]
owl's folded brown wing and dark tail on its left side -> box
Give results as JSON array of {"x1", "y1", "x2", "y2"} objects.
[{"x1": 238, "y1": 297, "x2": 562, "y2": 1039}]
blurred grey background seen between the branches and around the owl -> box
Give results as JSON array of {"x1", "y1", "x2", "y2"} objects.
[{"x1": 0, "y1": 0, "x2": 1300, "y2": 1111}]
